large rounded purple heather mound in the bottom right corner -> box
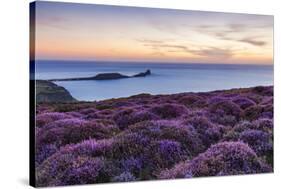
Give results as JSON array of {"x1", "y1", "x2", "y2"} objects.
[{"x1": 160, "y1": 142, "x2": 271, "y2": 178}]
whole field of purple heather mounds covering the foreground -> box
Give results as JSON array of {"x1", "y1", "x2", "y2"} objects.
[{"x1": 35, "y1": 86, "x2": 273, "y2": 186}]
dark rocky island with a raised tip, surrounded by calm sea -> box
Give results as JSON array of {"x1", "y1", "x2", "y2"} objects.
[{"x1": 49, "y1": 69, "x2": 151, "y2": 81}]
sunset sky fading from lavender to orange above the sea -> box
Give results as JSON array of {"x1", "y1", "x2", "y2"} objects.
[{"x1": 32, "y1": 1, "x2": 273, "y2": 64}]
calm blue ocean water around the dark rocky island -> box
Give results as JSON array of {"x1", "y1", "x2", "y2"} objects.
[{"x1": 35, "y1": 61, "x2": 273, "y2": 101}]
